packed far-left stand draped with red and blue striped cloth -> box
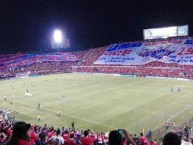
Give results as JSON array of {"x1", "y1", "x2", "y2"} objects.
[{"x1": 0, "y1": 50, "x2": 88, "y2": 79}]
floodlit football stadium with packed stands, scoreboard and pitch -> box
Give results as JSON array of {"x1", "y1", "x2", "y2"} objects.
[{"x1": 0, "y1": 1, "x2": 193, "y2": 145}]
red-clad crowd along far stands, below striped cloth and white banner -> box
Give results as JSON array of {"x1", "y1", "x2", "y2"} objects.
[{"x1": 0, "y1": 42, "x2": 193, "y2": 79}]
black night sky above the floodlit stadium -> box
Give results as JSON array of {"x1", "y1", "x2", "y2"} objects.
[{"x1": 0, "y1": 0, "x2": 193, "y2": 54}]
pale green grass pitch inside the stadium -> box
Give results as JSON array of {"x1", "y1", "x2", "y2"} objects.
[{"x1": 0, "y1": 74, "x2": 193, "y2": 133}]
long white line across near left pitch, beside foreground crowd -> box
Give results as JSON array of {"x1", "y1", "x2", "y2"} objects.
[{"x1": 14, "y1": 101, "x2": 117, "y2": 129}]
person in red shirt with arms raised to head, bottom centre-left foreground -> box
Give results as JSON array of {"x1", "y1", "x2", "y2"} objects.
[{"x1": 81, "y1": 130, "x2": 96, "y2": 145}]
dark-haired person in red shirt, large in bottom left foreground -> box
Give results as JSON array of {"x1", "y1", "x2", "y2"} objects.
[{"x1": 5, "y1": 122, "x2": 31, "y2": 145}]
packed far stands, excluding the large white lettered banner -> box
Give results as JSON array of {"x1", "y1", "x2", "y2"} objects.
[{"x1": 0, "y1": 39, "x2": 193, "y2": 79}]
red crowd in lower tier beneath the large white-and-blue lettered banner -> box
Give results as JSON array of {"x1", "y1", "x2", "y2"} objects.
[{"x1": 76, "y1": 65, "x2": 193, "y2": 79}]
